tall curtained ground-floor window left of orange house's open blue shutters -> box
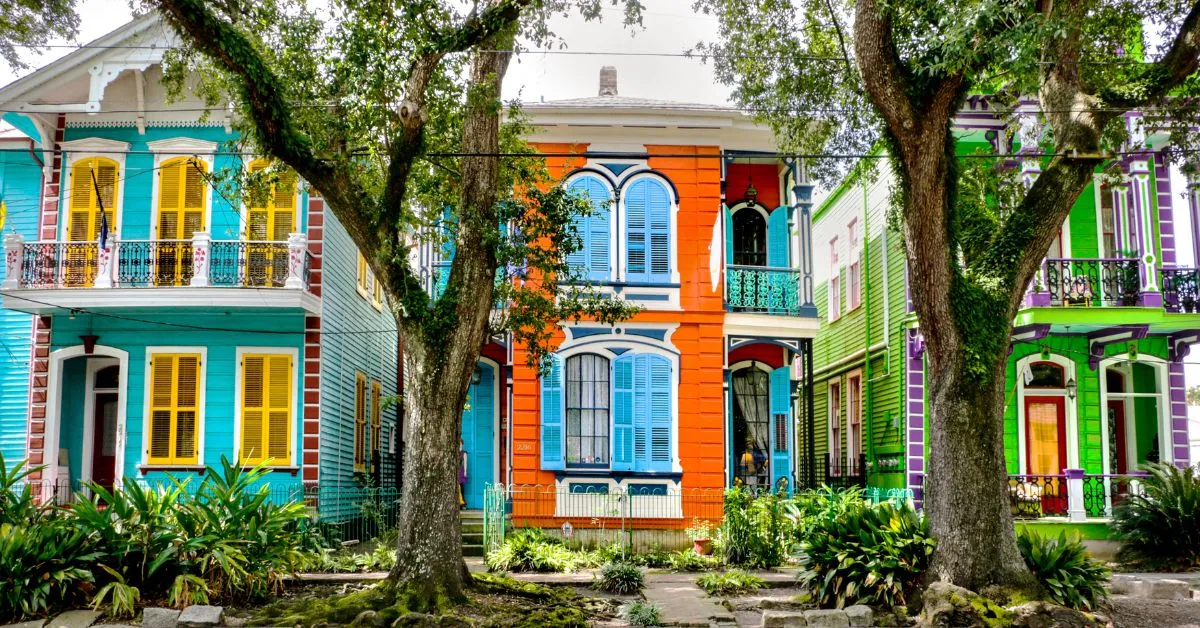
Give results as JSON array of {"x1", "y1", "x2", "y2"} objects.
[{"x1": 566, "y1": 353, "x2": 611, "y2": 466}]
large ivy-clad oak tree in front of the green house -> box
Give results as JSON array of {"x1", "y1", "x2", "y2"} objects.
[{"x1": 696, "y1": 0, "x2": 1200, "y2": 590}]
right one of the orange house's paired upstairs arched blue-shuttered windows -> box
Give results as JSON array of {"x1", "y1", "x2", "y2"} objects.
[{"x1": 624, "y1": 178, "x2": 671, "y2": 283}]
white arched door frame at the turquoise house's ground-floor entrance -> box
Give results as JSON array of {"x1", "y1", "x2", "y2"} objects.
[{"x1": 42, "y1": 345, "x2": 130, "y2": 498}]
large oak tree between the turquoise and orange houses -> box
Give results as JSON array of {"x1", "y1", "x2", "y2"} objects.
[{"x1": 146, "y1": 0, "x2": 640, "y2": 610}]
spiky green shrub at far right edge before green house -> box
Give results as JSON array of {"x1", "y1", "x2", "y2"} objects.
[{"x1": 1112, "y1": 463, "x2": 1200, "y2": 570}]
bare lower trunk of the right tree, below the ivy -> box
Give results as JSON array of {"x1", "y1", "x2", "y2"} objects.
[{"x1": 925, "y1": 342, "x2": 1037, "y2": 592}]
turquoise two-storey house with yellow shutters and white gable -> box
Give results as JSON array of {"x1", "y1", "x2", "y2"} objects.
[{"x1": 0, "y1": 16, "x2": 400, "y2": 511}]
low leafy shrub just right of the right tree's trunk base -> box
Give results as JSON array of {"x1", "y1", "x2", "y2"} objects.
[{"x1": 1016, "y1": 531, "x2": 1112, "y2": 610}]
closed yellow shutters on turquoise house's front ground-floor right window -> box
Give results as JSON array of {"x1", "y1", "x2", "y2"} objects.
[{"x1": 241, "y1": 353, "x2": 293, "y2": 466}]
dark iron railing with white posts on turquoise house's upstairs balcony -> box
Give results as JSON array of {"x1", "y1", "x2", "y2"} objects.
[{"x1": 0, "y1": 233, "x2": 312, "y2": 294}]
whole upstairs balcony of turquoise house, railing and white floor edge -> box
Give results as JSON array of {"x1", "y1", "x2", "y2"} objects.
[{"x1": 0, "y1": 232, "x2": 320, "y2": 313}]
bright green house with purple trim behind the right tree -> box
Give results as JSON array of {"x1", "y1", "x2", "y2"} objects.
[{"x1": 812, "y1": 102, "x2": 1200, "y2": 521}]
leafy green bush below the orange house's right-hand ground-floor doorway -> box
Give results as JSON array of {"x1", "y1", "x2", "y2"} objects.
[{"x1": 716, "y1": 486, "x2": 794, "y2": 567}]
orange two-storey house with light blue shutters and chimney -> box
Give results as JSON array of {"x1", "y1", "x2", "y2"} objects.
[{"x1": 436, "y1": 68, "x2": 817, "y2": 540}]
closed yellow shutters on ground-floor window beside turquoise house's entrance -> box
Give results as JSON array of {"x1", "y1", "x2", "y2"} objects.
[{"x1": 146, "y1": 353, "x2": 200, "y2": 465}]
